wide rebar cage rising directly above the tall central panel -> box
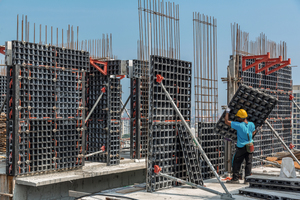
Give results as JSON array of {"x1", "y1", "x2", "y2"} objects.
[{"x1": 137, "y1": 0, "x2": 180, "y2": 61}]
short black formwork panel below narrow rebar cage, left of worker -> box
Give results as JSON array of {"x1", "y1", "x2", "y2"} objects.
[{"x1": 198, "y1": 122, "x2": 225, "y2": 180}]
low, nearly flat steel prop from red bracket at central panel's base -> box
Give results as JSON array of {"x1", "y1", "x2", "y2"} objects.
[{"x1": 154, "y1": 165, "x2": 231, "y2": 197}]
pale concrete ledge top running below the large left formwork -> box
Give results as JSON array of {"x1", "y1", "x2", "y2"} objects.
[{"x1": 16, "y1": 160, "x2": 146, "y2": 187}]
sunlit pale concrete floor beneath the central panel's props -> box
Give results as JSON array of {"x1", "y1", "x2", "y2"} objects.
[{"x1": 82, "y1": 179, "x2": 255, "y2": 200}]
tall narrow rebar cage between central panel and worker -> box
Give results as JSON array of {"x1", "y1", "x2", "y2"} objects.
[{"x1": 193, "y1": 13, "x2": 218, "y2": 123}]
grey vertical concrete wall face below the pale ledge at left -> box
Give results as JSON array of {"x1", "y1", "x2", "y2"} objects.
[{"x1": 14, "y1": 169, "x2": 146, "y2": 200}]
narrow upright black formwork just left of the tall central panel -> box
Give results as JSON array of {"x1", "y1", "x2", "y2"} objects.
[{"x1": 130, "y1": 60, "x2": 149, "y2": 159}]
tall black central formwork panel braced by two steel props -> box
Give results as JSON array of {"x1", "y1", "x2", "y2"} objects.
[{"x1": 146, "y1": 56, "x2": 191, "y2": 192}]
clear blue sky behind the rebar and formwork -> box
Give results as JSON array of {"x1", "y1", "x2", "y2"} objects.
[{"x1": 0, "y1": 0, "x2": 300, "y2": 115}]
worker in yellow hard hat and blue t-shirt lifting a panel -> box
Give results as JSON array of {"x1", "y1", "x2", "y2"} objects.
[{"x1": 225, "y1": 107, "x2": 261, "y2": 184}]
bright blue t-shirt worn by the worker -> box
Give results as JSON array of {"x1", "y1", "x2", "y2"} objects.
[{"x1": 231, "y1": 122, "x2": 255, "y2": 148}]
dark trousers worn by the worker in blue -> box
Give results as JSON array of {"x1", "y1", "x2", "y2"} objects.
[{"x1": 232, "y1": 146, "x2": 253, "y2": 180}]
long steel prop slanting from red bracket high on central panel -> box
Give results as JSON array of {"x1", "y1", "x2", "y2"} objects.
[{"x1": 156, "y1": 74, "x2": 233, "y2": 199}]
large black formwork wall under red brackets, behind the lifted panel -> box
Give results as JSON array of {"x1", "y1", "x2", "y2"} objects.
[{"x1": 239, "y1": 59, "x2": 292, "y2": 166}]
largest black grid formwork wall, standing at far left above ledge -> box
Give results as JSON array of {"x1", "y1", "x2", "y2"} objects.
[{"x1": 6, "y1": 41, "x2": 89, "y2": 175}]
